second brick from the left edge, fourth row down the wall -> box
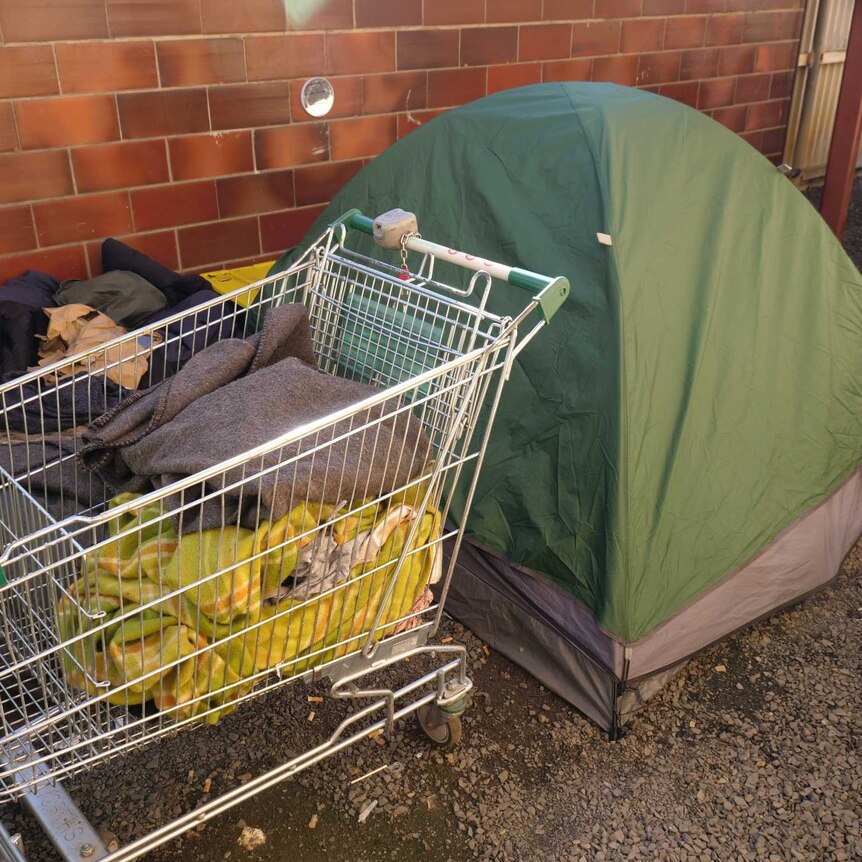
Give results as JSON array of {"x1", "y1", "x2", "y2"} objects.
[{"x1": 72, "y1": 140, "x2": 170, "y2": 192}]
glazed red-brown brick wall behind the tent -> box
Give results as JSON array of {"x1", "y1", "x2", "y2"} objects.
[{"x1": 0, "y1": 0, "x2": 804, "y2": 281}]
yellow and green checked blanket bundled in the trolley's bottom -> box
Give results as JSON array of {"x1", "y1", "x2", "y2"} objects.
[{"x1": 58, "y1": 487, "x2": 440, "y2": 723}]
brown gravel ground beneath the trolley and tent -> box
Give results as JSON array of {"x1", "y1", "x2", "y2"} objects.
[{"x1": 5, "y1": 179, "x2": 862, "y2": 862}]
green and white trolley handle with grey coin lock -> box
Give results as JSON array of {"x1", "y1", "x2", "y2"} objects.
[{"x1": 333, "y1": 209, "x2": 570, "y2": 321}]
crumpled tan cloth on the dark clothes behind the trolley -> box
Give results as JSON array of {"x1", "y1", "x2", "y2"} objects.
[{"x1": 37, "y1": 303, "x2": 148, "y2": 389}]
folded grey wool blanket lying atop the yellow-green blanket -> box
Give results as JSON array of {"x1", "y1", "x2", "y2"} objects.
[{"x1": 79, "y1": 304, "x2": 429, "y2": 533}]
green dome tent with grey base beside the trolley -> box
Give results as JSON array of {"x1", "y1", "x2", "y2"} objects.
[{"x1": 268, "y1": 83, "x2": 862, "y2": 730}]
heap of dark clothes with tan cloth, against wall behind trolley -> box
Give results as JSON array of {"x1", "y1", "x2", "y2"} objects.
[{"x1": 0, "y1": 239, "x2": 246, "y2": 519}]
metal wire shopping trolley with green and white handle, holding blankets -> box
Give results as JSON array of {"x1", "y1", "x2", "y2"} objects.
[{"x1": 0, "y1": 210, "x2": 569, "y2": 862}]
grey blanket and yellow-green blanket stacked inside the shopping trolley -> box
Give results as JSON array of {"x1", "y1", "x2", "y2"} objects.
[{"x1": 45, "y1": 304, "x2": 441, "y2": 722}]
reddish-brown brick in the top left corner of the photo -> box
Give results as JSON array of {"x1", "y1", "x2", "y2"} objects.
[{"x1": 0, "y1": 0, "x2": 108, "y2": 42}]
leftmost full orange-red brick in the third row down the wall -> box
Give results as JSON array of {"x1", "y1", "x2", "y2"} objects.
[{"x1": 15, "y1": 96, "x2": 120, "y2": 149}]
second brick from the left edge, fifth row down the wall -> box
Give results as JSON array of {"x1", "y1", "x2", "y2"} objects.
[{"x1": 33, "y1": 192, "x2": 132, "y2": 245}]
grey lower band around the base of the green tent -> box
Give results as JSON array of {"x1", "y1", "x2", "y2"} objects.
[{"x1": 446, "y1": 462, "x2": 862, "y2": 736}]
